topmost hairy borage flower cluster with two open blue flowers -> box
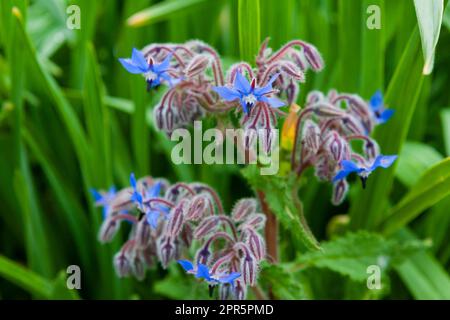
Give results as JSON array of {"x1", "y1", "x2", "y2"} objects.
[{"x1": 119, "y1": 39, "x2": 323, "y2": 150}]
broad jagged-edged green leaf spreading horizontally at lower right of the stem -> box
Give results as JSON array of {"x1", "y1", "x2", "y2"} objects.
[{"x1": 297, "y1": 231, "x2": 424, "y2": 281}]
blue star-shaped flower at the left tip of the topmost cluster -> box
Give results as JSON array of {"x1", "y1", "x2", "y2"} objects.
[{"x1": 119, "y1": 48, "x2": 175, "y2": 90}]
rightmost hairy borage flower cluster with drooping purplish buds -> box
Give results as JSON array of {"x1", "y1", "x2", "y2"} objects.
[{"x1": 292, "y1": 90, "x2": 397, "y2": 205}]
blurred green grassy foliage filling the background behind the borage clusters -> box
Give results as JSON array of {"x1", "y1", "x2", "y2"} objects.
[{"x1": 0, "y1": 0, "x2": 450, "y2": 299}]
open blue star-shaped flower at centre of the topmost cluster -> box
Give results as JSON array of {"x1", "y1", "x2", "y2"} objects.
[{"x1": 213, "y1": 72, "x2": 285, "y2": 114}]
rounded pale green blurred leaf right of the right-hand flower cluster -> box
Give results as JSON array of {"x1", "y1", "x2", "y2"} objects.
[{"x1": 395, "y1": 142, "x2": 443, "y2": 188}]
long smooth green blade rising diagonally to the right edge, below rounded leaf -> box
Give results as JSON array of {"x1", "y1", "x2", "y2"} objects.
[{"x1": 381, "y1": 157, "x2": 450, "y2": 234}]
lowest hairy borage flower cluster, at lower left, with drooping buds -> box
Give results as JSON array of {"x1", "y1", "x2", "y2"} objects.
[{"x1": 92, "y1": 174, "x2": 266, "y2": 299}]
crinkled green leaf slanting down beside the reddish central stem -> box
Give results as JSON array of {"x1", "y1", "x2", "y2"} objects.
[{"x1": 241, "y1": 165, "x2": 320, "y2": 250}]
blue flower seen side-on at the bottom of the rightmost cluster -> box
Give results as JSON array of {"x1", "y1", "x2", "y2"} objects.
[{"x1": 333, "y1": 155, "x2": 397, "y2": 188}]
